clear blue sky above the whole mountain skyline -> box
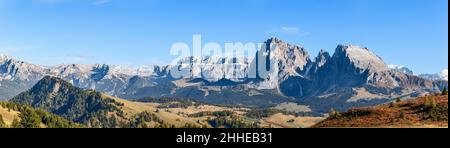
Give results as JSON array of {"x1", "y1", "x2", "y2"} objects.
[{"x1": 0, "y1": 0, "x2": 448, "y2": 73}]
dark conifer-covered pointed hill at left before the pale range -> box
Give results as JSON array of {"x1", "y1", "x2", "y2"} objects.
[{"x1": 10, "y1": 76, "x2": 130, "y2": 127}]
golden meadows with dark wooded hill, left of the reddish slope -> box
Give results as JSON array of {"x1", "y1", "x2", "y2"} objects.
[{"x1": 0, "y1": 77, "x2": 321, "y2": 128}]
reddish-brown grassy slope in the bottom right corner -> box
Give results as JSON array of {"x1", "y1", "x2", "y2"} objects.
[{"x1": 313, "y1": 95, "x2": 448, "y2": 128}]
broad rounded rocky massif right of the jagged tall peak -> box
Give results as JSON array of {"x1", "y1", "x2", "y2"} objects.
[{"x1": 318, "y1": 45, "x2": 391, "y2": 89}]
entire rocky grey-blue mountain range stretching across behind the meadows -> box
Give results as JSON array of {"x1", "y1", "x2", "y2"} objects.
[{"x1": 0, "y1": 38, "x2": 448, "y2": 113}]
